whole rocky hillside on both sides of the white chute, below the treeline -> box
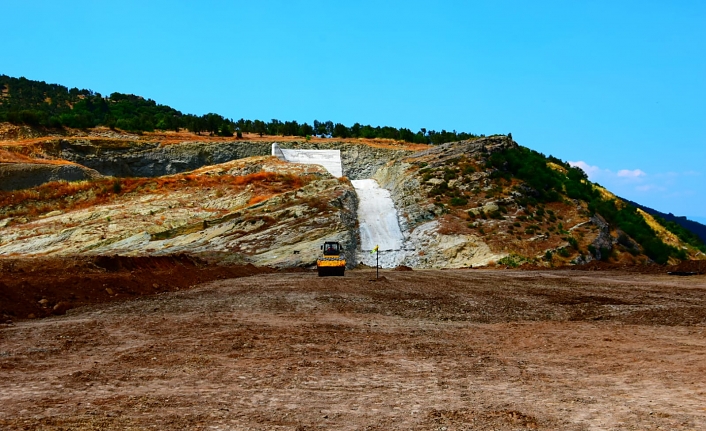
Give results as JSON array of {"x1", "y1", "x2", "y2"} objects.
[{"x1": 0, "y1": 124, "x2": 706, "y2": 268}]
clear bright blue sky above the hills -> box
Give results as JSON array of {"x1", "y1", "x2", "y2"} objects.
[{"x1": 0, "y1": 0, "x2": 706, "y2": 223}]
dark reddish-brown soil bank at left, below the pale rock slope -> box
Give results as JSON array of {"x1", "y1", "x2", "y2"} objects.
[{"x1": 0, "y1": 255, "x2": 271, "y2": 323}]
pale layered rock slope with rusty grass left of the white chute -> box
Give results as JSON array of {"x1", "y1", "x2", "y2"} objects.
[{"x1": 0, "y1": 157, "x2": 358, "y2": 267}]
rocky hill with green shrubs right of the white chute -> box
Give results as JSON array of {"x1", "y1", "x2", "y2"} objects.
[{"x1": 375, "y1": 137, "x2": 706, "y2": 266}]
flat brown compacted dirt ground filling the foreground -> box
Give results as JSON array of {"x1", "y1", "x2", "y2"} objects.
[{"x1": 0, "y1": 261, "x2": 706, "y2": 430}]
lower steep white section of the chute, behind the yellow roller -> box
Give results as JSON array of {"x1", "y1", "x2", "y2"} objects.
[{"x1": 351, "y1": 179, "x2": 404, "y2": 268}]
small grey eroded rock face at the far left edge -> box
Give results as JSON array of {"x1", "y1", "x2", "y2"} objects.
[{"x1": 0, "y1": 163, "x2": 101, "y2": 191}]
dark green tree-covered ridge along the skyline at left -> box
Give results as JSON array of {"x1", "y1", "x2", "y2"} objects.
[{"x1": 0, "y1": 74, "x2": 483, "y2": 145}]
